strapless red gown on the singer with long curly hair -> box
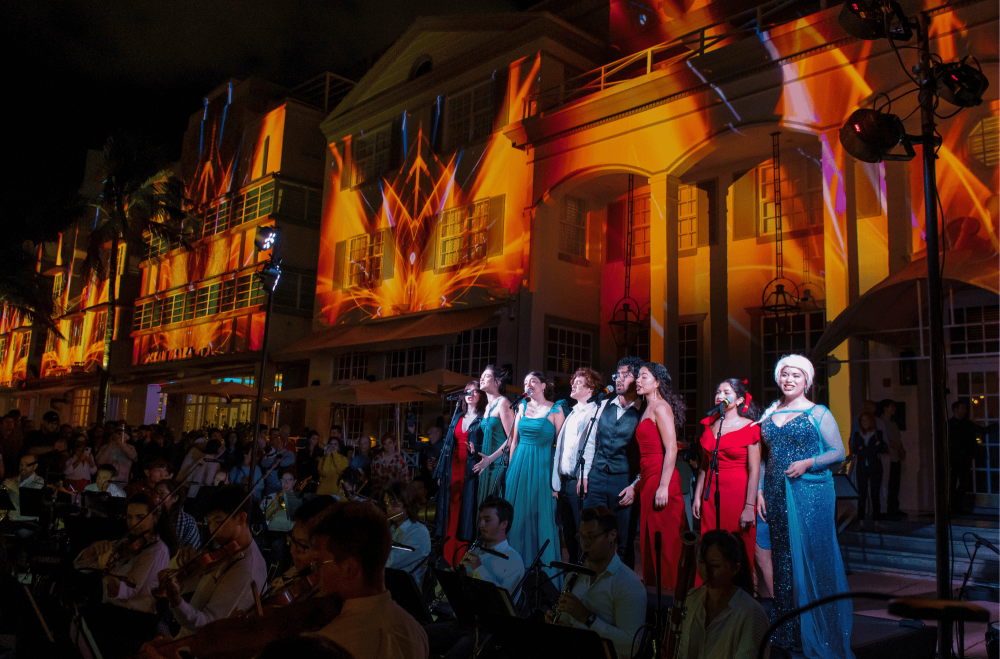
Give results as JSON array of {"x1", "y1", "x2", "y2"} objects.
[{"x1": 635, "y1": 419, "x2": 687, "y2": 590}]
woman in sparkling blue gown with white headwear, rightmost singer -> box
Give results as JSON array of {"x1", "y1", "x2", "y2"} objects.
[{"x1": 757, "y1": 355, "x2": 854, "y2": 659}]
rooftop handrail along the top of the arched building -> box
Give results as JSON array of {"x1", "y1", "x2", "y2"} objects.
[{"x1": 521, "y1": 0, "x2": 827, "y2": 120}]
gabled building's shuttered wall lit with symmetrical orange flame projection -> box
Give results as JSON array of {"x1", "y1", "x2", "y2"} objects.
[{"x1": 316, "y1": 58, "x2": 539, "y2": 325}]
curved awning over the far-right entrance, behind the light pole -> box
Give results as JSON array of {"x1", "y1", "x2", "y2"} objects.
[{"x1": 812, "y1": 250, "x2": 1000, "y2": 359}]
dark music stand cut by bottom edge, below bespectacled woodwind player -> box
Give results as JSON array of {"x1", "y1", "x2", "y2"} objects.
[{"x1": 484, "y1": 616, "x2": 618, "y2": 659}]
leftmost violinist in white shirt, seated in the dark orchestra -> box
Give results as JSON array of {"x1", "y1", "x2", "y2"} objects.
[{"x1": 73, "y1": 492, "x2": 173, "y2": 657}]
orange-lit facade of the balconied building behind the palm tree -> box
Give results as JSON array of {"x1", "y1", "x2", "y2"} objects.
[{"x1": 132, "y1": 94, "x2": 286, "y2": 364}]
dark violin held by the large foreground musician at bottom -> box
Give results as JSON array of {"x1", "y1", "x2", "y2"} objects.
[{"x1": 132, "y1": 595, "x2": 344, "y2": 659}]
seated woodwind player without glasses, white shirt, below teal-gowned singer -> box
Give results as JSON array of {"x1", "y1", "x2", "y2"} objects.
[{"x1": 459, "y1": 496, "x2": 524, "y2": 599}]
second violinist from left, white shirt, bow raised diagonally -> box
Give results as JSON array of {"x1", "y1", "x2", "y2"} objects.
[{"x1": 160, "y1": 485, "x2": 267, "y2": 638}]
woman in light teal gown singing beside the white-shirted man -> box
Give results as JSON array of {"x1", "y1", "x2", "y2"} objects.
[{"x1": 504, "y1": 371, "x2": 566, "y2": 576}]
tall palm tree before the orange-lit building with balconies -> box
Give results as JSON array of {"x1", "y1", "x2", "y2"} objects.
[{"x1": 83, "y1": 134, "x2": 189, "y2": 423}]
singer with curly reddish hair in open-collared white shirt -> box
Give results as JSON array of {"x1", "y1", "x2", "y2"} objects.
[{"x1": 552, "y1": 368, "x2": 604, "y2": 561}]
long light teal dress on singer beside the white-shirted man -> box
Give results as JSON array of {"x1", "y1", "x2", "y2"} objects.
[{"x1": 504, "y1": 404, "x2": 560, "y2": 576}]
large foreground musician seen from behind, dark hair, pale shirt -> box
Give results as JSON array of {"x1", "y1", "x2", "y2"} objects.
[{"x1": 312, "y1": 501, "x2": 428, "y2": 659}]
